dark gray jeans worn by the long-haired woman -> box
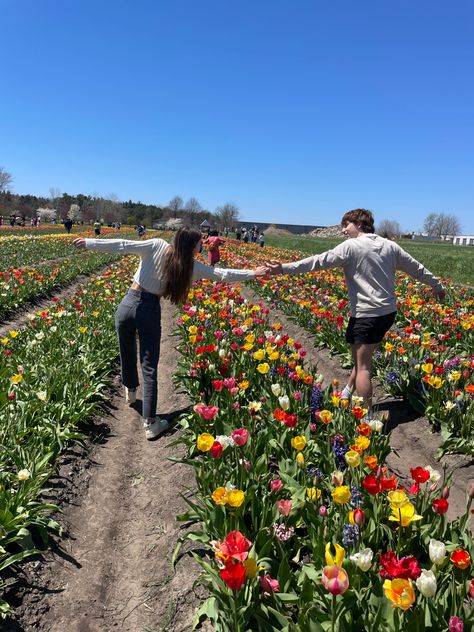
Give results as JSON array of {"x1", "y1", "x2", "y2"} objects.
[{"x1": 115, "y1": 290, "x2": 161, "y2": 419}]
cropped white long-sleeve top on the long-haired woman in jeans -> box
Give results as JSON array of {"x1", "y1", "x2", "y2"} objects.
[{"x1": 85, "y1": 238, "x2": 255, "y2": 295}]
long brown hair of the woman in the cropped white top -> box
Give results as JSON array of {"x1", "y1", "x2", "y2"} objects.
[{"x1": 163, "y1": 226, "x2": 202, "y2": 303}]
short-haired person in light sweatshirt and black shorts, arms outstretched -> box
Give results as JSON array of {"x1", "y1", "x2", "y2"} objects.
[{"x1": 267, "y1": 209, "x2": 445, "y2": 419}]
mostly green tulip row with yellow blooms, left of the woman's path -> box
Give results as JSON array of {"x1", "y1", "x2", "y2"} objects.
[{"x1": 0, "y1": 260, "x2": 136, "y2": 617}]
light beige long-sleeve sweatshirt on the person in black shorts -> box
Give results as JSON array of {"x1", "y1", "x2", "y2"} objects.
[{"x1": 282, "y1": 233, "x2": 443, "y2": 318}]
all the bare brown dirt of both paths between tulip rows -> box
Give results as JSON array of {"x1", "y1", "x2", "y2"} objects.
[{"x1": 2, "y1": 289, "x2": 474, "y2": 632}]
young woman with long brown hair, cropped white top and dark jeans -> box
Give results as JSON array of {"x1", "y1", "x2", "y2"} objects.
[{"x1": 73, "y1": 227, "x2": 266, "y2": 439}]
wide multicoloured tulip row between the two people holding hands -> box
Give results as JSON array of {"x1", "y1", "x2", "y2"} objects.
[{"x1": 176, "y1": 272, "x2": 474, "y2": 632}]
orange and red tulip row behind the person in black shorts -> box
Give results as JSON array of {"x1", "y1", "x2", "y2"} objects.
[{"x1": 214, "y1": 237, "x2": 474, "y2": 456}]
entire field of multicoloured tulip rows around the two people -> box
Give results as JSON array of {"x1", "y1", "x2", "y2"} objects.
[{"x1": 0, "y1": 234, "x2": 474, "y2": 632}]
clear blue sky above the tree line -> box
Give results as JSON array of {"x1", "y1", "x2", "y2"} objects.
[{"x1": 0, "y1": 0, "x2": 474, "y2": 234}]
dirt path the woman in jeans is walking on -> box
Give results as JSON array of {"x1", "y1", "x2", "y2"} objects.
[{"x1": 5, "y1": 301, "x2": 205, "y2": 632}]
